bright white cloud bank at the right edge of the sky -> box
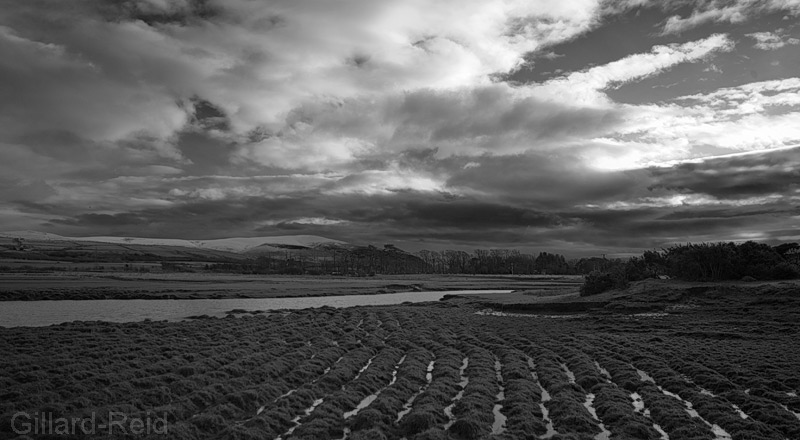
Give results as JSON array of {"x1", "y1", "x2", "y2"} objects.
[{"x1": 585, "y1": 78, "x2": 800, "y2": 169}]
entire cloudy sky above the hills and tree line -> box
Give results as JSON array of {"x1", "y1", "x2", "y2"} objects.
[{"x1": 0, "y1": 0, "x2": 800, "y2": 256}]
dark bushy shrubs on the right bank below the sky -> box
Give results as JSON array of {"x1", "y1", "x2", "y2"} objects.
[{"x1": 581, "y1": 241, "x2": 800, "y2": 295}]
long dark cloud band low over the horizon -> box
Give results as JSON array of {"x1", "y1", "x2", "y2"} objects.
[{"x1": 12, "y1": 145, "x2": 800, "y2": 255}]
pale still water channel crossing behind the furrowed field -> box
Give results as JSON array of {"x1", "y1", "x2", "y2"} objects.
[{"x1": 0, "y1": 290, "x2": 510, "y2": 327}]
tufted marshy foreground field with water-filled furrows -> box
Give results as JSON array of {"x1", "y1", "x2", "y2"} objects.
[{"x1": 0, "y1": 280, "x2": 800, "y2": 440}]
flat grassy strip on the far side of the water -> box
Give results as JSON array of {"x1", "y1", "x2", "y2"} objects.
[{"x1": 0, "y1": 272, "x2": 582, "y2": 301}]
